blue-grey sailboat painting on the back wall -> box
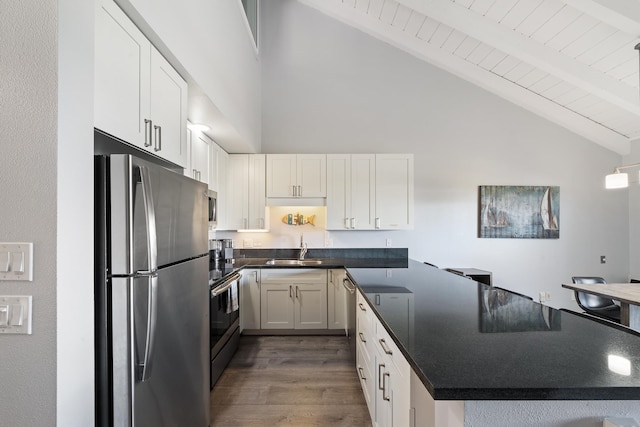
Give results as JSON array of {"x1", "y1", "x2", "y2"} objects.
[{"x1": 478, "y1": 185, "x2": 560, "y2": 239}]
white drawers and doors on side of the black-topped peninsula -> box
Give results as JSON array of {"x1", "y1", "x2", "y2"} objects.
[{"x1": 356, "y1": 292, "x2": 411, "y2": 427}]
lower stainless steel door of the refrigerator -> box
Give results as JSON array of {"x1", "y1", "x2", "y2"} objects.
[{"x1": 112, "y1": 257, "x2": 209, "y2": 427}]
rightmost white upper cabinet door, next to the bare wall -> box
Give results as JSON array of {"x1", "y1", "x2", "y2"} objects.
[{"x1": 375, "y1": 154, "x2": 413, "y2": 230}]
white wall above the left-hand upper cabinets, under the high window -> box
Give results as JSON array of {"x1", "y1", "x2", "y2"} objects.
[{"x1": 116, "y1": 0, "x2": 261, "y2": 152}]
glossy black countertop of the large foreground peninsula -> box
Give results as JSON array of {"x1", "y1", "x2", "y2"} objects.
[{"x1": 348, "y1": 260, "x2": 640, "y2": 400}]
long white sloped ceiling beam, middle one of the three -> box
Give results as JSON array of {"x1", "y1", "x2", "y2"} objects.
[{"x1": 399, "y1": 0, "x2": 640, "y2": 116}]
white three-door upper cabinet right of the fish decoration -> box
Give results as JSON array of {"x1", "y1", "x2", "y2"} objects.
[{"x1": 327, "y1": 154, "x2": 414, "y2": 230}]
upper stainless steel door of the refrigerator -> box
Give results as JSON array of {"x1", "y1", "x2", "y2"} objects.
[{"x1": 106, "y1": 154, "x2": 209, "y2": 275}]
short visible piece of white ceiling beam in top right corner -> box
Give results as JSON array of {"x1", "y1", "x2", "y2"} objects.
[{"x1": 564, "y1": 0, "x2": 640, "y2": 37}]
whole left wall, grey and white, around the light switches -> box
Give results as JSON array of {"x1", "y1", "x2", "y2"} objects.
[{"x1": 0, "y1": 0, "x2": 93, "y2": 426}]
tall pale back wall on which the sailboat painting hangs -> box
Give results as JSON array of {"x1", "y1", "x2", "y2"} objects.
[{"x1": 261, "y1": 0, "x2": 629, "y2": 308}]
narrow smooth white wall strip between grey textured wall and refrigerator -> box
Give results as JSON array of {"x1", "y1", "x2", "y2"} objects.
[{"x1": 57, "y1": 0, "x2": 95, "y2": 427}]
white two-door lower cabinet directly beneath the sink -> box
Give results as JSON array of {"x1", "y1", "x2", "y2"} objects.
[{"x1": 260, "y1": 268, "x2": 327, "y2": 329}]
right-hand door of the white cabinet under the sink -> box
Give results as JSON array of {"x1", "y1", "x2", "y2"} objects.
[{"x1": 294, "y1": 282, "x2": 327, "y2": 329}]
